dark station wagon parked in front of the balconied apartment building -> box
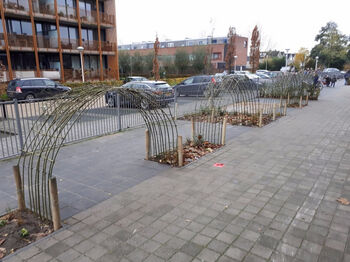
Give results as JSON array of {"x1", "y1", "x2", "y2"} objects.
[{"x1": 7, "y1": 78, "x2": 71, "y2": 100}]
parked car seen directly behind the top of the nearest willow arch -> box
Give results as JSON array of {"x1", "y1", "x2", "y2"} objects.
[{"x1": 105, "y1": 80, "x2": 174, "y2": 109}]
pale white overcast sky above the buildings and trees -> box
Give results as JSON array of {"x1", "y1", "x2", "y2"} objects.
[{"x1": 116, "y1": 0, "x2": 350, "y2": 52}]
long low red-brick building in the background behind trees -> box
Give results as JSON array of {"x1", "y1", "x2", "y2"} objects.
[{"x1": 118, "y1": 35, "x2": 248, "y2": 72}]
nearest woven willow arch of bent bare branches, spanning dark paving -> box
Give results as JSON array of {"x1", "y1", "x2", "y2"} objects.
[{"x1": 18, "y1": 85, "x2": 177, "y2": 219}]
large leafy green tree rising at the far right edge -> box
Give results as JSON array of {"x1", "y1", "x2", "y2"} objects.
[{"x1": 311, "y1": 22, "x2": 349, "y2": 69}]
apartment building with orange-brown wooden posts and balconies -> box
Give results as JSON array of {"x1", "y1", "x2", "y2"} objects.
[{"x1": 0, "y1": 0, "x2": 119, "y2": 81}]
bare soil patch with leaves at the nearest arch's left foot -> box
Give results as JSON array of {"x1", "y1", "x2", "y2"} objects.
[{"x1": 0, "y1": 210, "x2": 53, "y2": 259}]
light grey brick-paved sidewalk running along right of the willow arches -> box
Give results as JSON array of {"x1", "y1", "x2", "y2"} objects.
[{"x1": 5, "y1": 84, "x2": 350, "y2": 262}]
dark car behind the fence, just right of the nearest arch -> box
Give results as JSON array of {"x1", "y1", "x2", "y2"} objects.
[{"x1": 173, "y1": 75, "x2": 216, "y2": 96}]
